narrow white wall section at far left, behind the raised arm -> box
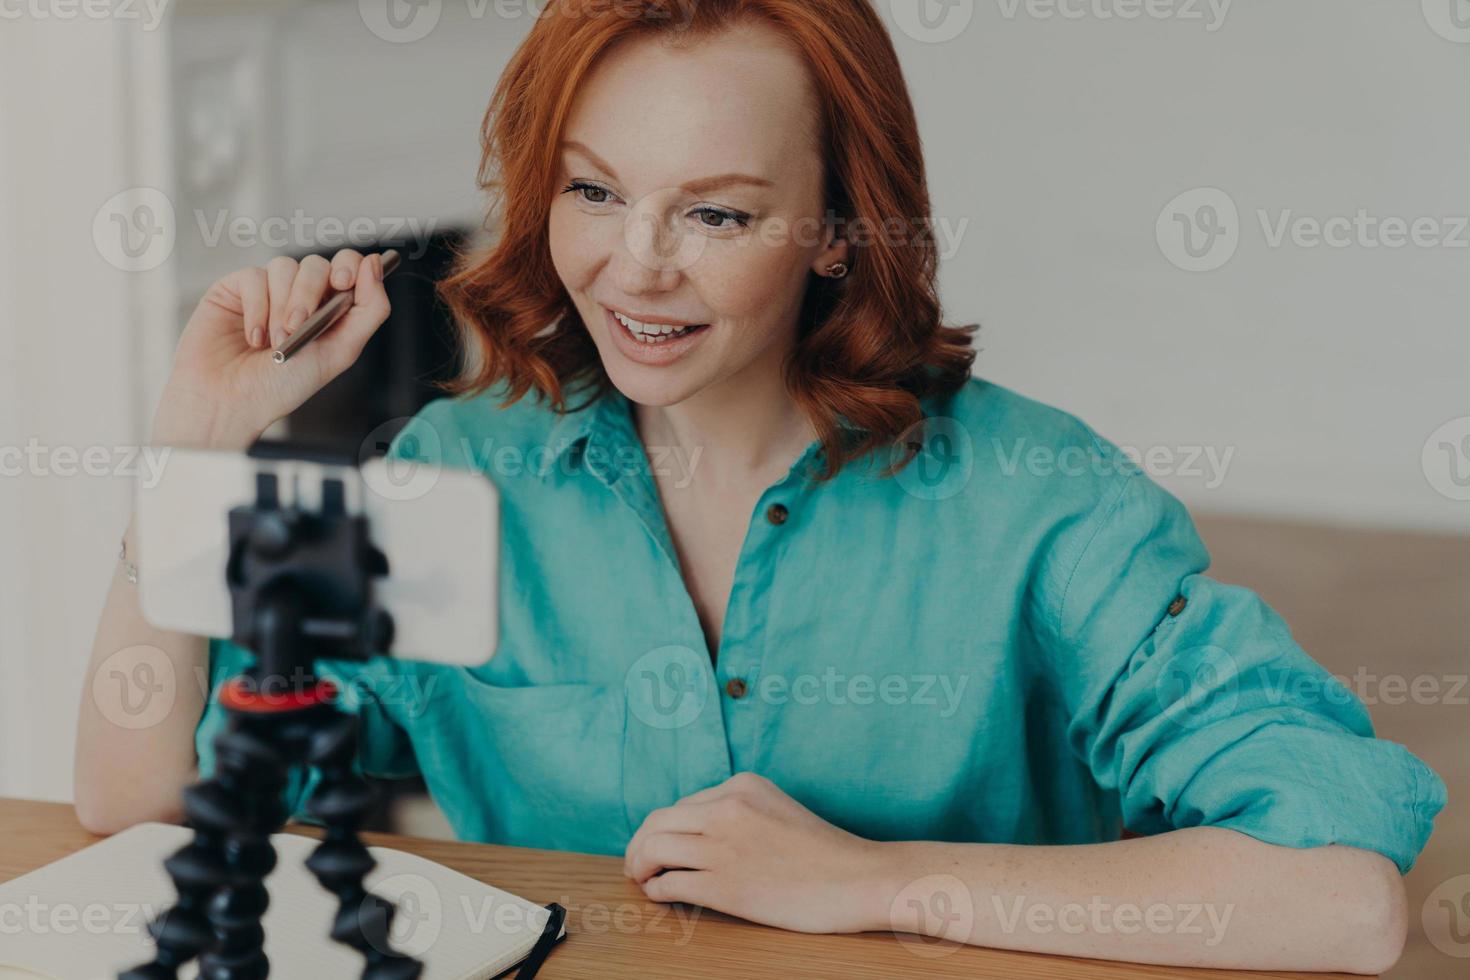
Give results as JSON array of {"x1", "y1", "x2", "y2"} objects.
[{"x1": 0, "y1": 21, "x2": 149, "y2": 799}]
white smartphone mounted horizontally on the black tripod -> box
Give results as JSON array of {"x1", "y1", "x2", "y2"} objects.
[{"x1": 134, "y1": 444, "x2": 500, "y2": 667}]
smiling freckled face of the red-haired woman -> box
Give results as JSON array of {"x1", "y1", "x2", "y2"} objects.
[{"x1": 548, "y1": 25, "x2": 847, "y2": 406}]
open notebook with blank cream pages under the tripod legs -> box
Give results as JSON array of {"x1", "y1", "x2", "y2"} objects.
[{"x1": 0, "y1": 823, "x2": 564, "y2": 980}]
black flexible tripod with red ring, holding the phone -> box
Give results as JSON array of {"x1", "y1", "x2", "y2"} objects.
[{"x1": 119, "y1": 461, "x2": 423, "y2": 980}]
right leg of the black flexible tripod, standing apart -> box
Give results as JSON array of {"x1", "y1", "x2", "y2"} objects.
[{"x1": 306, "y1": 708, "x2": 423, "y2": 980}]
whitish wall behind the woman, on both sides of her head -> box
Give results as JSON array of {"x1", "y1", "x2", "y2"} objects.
[{"x1": 0, "y1": 0, "x2": 1470, "y2": 799}]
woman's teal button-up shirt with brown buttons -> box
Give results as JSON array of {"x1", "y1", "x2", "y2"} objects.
[{"x1": 196, "y1": 379, "x2": 1445, "y2": 871}]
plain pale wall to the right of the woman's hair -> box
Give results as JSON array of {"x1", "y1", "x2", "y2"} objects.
[{"x1": 885, "y1": 0, "x2": 1470, "y2": 533}]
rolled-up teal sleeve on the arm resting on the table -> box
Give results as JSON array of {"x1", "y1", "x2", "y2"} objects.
[{"x1": 1051, "y1": 470, "x2": 1445, "y2": 873}]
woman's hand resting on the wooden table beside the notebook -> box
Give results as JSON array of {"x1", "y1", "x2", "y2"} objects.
[{"x1": 623, "y1": 773, "x2": 891, "y2": 933}]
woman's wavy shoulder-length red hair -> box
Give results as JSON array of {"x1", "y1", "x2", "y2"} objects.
[{"x1": 438, "y1": 0, "x2": 976, "y2": 479}]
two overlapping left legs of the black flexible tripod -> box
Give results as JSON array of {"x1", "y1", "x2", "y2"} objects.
[{"x1": 119, "y1": 711, "x2": 300, "y2": 980}]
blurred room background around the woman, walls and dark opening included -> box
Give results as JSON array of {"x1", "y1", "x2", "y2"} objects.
[{"x1": 0, "y1": 0, "x2": 1470, "y2": 979}]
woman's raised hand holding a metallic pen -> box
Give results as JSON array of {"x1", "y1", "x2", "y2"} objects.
[{"x1": 153, "y1": 248, "x2": 390, "y2": 451}]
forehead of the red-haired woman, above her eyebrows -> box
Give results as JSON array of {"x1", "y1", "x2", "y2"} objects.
[{"x1": 564, "y1": 25, "x2": 820, "y2": 192}]
